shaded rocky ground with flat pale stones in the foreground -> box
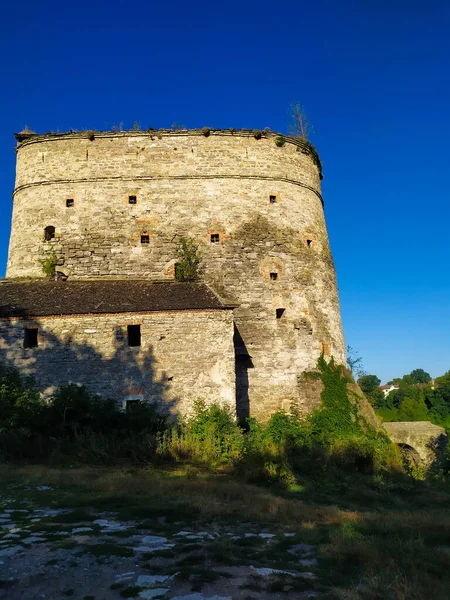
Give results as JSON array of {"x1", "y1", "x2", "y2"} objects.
[{"x1": 0, "y1": 485, "x2": 321, "y2": 600}]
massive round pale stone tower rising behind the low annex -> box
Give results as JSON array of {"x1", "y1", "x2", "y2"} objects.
[{"x1": 7, "y1": 130, "x2": 345, "y2": 417}]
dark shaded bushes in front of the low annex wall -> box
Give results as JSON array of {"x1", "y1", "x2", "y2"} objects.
[{"x1": 0, "y1": 366, "x2": 167, "y2": 464}]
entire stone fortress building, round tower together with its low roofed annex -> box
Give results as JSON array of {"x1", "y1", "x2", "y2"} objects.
[{"x1": 0, "y1": 130, "x2": 345, "y2": 417}]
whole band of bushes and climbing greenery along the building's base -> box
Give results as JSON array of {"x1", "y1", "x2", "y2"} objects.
[{"x1": 0, "y1": 357, "x2": 401, "y2": 484}]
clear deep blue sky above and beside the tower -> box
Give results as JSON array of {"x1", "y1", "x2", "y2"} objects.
[{"x1": 0, "y1": 0, "x2": 450, "y2": 382}]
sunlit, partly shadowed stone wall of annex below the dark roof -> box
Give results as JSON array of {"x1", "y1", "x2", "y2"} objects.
[{"x1": 0, "y1": 310, "x2": 235, "y2": 414}]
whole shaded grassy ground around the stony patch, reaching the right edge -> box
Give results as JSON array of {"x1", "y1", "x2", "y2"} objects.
[{"x1": 0, "y1": 465, "x2": 450, "y2": 600}]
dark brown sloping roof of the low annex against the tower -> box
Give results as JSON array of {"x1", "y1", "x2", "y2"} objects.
[{"x1": 0, "y1": 279, "x2": 234, "y2": 317}]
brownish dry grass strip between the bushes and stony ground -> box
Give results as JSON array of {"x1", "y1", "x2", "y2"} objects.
[{"x1": 0, "y1": 467, "x2": 348, "y2": 527}]
